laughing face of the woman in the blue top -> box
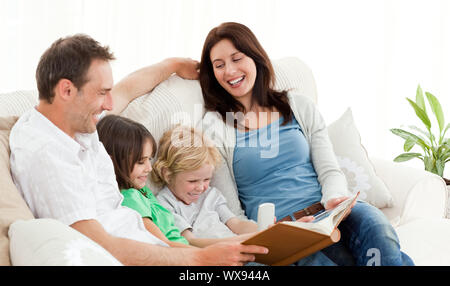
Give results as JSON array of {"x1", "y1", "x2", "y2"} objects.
[{"x1": 210, "y1": 39, "x2": 256, "y2": 101}]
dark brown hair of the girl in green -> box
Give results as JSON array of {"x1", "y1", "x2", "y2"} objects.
[{"x1": 97, "y1": 115, "x2": 156, "y2": 190}]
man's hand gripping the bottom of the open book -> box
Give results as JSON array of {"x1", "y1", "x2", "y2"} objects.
[{"x1": 197, "y1": 242, "x2": 269, "y2": 266}]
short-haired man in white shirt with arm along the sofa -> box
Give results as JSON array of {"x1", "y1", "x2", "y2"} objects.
[{"x1": 10, "y1": 35, "x2": 267, "y2": 265}]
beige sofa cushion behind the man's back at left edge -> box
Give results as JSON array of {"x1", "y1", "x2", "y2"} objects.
[{"x1": 0, "y1": 116, "x2": 33, "y2": 265}]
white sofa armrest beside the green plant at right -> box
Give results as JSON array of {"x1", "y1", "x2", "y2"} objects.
[{"x1": 371, "y1": 158, "x2": 447, "y2": 225}]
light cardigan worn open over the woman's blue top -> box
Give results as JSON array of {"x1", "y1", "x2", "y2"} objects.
[{"x1": 197, "y1": 92, "x2": 350, "y2": 218}]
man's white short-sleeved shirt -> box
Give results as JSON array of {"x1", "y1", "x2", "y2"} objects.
[{"x1": 9, "y1": 108, "x2": 167, "y2": 246}]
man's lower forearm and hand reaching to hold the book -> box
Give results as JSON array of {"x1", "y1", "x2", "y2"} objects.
[{"x1": 71, "y1": 220, "x2": 268, "y2": 266}]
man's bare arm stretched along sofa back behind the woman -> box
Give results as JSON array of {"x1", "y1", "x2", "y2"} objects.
[{"x1": 107, "y1": 58, "x2": 198, "y2": 114}]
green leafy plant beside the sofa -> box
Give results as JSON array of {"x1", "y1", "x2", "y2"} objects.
[{"x1": 391, "y1": 85, "x2": 450, "y2": 185}]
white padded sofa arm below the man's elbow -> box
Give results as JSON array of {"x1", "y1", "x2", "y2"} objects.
[{"x1": 8, "y1": 219, "x2": 122, "y2": 266}]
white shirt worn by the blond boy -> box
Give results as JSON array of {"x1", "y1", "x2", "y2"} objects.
[{"x1": 157, "y1": 187, "x2": 235, "y2": 238}]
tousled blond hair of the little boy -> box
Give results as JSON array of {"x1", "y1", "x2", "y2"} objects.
[{"x1": 151, "y1": 125, "x2": 221, "y2": 186}]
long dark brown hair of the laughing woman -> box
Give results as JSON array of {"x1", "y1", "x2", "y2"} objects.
[{"x1": 199, "y1": 22, "x2": 292, "y2": 124}]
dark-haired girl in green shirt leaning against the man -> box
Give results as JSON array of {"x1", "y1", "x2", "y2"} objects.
[{"x1": 97, "y1": 115, "x2": 189, "y2": 247}]
